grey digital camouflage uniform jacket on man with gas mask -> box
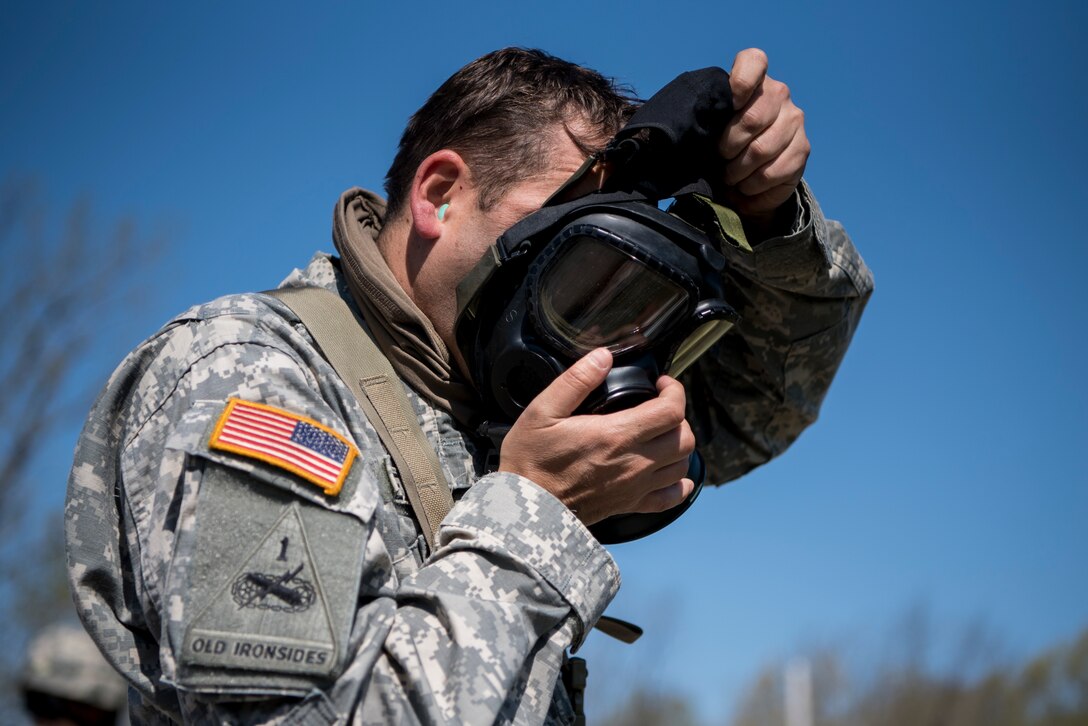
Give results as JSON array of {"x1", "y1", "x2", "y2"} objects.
[{"x1": 66, "y1": 182, "x2": 871, "y2": 724}]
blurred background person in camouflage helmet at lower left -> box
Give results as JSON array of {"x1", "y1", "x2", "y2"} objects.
[{"x1": 20, "y1": 623, "x2": 126, "y2": 726}]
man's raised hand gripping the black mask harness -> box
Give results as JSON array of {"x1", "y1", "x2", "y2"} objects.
[{"x1": 719, "y1": 48, "x2": 812, "y2": 218}]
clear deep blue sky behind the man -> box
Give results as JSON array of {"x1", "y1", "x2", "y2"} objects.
[{"x1": 0, "y1": 1, "x2": 1088, "y2": 719}]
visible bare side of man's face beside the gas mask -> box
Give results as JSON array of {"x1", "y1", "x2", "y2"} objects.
[{"x1": 415, "y1": 127, "x2": 585, "y2": 371}]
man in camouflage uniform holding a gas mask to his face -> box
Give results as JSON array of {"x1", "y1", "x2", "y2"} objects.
[{"x1": 66, "y1": 49, "x2": 871, "y2": 724}]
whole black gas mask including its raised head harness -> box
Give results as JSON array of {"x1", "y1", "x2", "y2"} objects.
[{"x1": 455, "y1": 69, "x2": 746, "y2": 544}]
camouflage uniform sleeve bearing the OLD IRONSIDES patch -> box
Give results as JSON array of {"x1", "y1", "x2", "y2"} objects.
[{"x1": 74, "y1": 304, "x2": 619, "y2": 724}]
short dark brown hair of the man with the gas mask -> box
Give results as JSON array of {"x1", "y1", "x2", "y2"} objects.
[{"x1": 385, "y1": 48, "x2": 635, "y2": 218}]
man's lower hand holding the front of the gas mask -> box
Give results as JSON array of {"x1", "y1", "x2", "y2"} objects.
[{"x1": 499, "y1": 348, "x2": 695, "y2": 525}]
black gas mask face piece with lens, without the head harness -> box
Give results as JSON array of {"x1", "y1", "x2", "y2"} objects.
[{"x1": 456, "y1": 195, "x2": 738, "y2": 544}]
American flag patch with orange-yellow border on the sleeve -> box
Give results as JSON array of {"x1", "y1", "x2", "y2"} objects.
[{"x1": 208, "y1": 398, "x2": 359, "y2": 494}]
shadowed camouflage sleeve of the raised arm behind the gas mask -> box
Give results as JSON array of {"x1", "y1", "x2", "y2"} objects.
[{"x1": 681, "y1": 183, "x2": 873, "y2": 483}]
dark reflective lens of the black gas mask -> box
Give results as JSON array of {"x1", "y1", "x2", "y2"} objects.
[{"x1": 535, "y1": 227, "x2": 689, "y2": 354}]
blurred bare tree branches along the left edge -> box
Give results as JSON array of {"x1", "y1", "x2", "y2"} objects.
[{"x1": 0, "y1": 177, "x2": 164, "y2": 723}]
